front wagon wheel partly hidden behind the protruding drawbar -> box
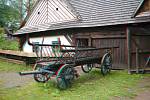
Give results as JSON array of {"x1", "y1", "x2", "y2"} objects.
[{"x1": 33, "y1": 64, "x2": 50, "y2": 83}]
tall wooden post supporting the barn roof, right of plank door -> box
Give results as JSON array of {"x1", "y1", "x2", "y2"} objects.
[{"x1": 126, "y1": 27, "x2": 132, "y2": 74}]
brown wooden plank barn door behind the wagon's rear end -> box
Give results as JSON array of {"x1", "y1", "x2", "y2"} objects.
[{"x1": 92, "y1": 38, "x2": 127, "y2": 69}]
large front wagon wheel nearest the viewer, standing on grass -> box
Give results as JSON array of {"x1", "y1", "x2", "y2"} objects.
[{"x1": 56, "y1": 64, "x2": 74, "y2": 90}]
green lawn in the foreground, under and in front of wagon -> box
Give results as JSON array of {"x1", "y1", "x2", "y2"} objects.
[{"x1": 0, "y1": 60, "x2": 150, "y2": 100}]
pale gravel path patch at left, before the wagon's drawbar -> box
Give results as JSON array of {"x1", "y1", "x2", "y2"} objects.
[{"x1": 0, "y1": 72, "x2": 33, "y2": 88}]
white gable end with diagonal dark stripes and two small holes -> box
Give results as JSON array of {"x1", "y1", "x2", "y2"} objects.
[{"x1": 25, "y1": 0, "x2": 78, "y2": 26}]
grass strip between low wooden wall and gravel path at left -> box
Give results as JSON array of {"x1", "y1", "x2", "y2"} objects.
[{"x1": 0, "y1": 60, "x2": 31, "y2": 72}]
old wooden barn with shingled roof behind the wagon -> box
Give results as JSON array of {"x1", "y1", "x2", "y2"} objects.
[{"x1": 14, "y1": 0, "x2": 150, "y2": 73}]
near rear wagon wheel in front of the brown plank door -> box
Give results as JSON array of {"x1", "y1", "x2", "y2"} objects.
[{"x1": 101, "y1": 53, "x2": 112, "y2": 75}]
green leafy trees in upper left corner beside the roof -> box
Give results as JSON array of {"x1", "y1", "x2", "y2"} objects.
[{"x1": 0, "y1": 0, "x2": 37, "y2": 29}]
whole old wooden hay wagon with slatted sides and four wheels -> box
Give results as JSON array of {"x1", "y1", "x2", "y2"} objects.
[{"x1": 19, "y1": 39, "x2": 117, "y2": 89}]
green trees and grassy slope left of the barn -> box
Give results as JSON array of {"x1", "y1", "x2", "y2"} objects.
[{"x1": 0, "y1": 0, "x2": 36, "y2": 50}]
